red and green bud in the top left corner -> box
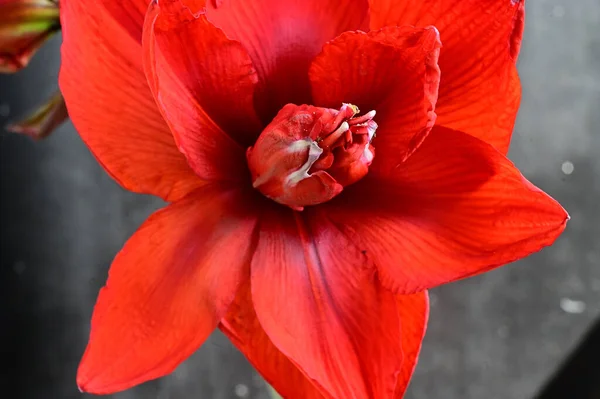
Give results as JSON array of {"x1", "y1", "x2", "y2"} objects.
[{"x1": 0, "y1": 0, "x2": 60, "y2": 73}]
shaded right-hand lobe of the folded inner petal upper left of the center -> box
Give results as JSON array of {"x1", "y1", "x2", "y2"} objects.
[{"x1": 143, "y1": 1, "x2": 262, "y2": 148}]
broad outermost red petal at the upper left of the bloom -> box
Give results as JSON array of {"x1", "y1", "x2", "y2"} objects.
[{"x1": 60, "y1": 0, "x2": 203, "y2": 201}]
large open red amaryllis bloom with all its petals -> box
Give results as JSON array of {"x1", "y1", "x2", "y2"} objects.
[{"x1": 60, "y1": 0, "x2": 568, "y2": 399}]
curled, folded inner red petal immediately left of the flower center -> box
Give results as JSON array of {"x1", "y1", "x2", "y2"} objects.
[{"x1": 144, "y1": 0, "x2": 253, "y2": 180}]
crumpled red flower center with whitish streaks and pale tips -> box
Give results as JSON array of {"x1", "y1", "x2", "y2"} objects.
[{"x1": 246, "y1": 104, "x2": 377, "y2": 211}]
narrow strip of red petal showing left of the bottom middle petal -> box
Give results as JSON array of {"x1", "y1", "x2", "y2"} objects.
[{"x1": 220, "y1": 284, "x2": 326, "y2": 399}]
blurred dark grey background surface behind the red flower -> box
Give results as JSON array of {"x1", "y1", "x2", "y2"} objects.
[{"x1": 0, "y1": 0, "x2": 600, "y2": 399}]
